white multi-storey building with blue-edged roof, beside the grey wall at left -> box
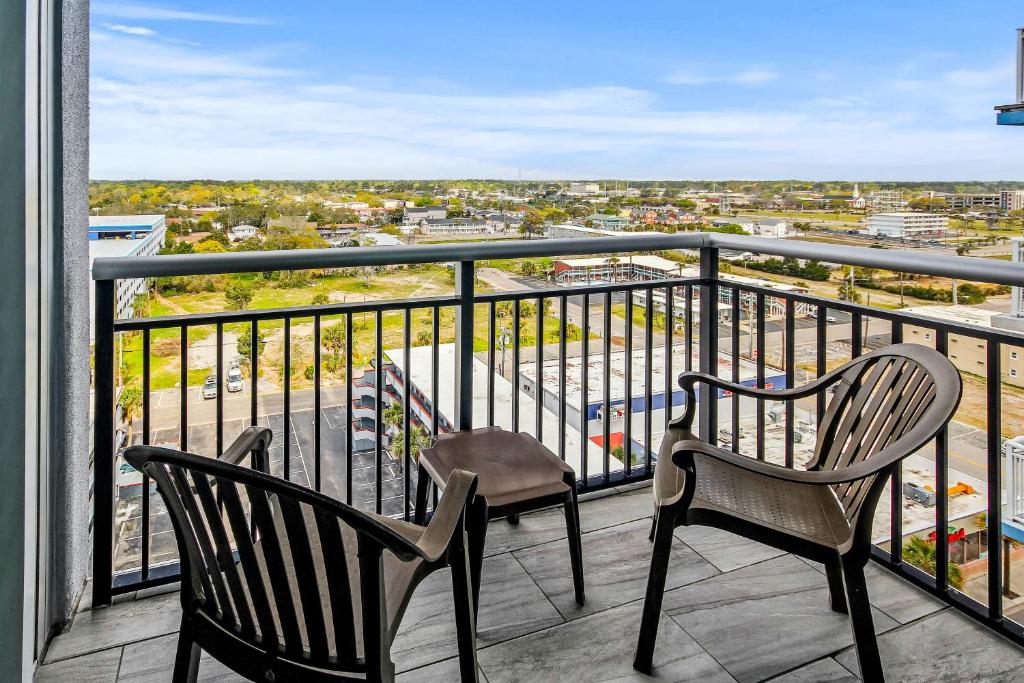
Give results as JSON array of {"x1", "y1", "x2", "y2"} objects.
[{"x1": 89, "y1": 216, "x2": 167, "y2": 327}]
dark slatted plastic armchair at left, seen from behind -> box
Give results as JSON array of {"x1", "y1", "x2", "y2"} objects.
[{"x1": 125, "y1": 430, "x2": 477, "y2": 683}]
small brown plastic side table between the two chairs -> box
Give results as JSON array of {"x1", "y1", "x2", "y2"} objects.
[{"x1": 416, "y1": 427, "x2": 586, "y2": 605}]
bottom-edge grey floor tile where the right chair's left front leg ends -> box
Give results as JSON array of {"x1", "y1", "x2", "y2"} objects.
[{"x1": 479, "y1": 602, "x2": 732, "y2": 683}]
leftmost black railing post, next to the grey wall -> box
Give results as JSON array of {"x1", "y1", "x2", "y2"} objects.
[{"x1": 92, "y1": 280, "x2": 115, "y2": 606}]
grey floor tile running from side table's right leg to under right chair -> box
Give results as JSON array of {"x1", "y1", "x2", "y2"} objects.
[{"x1": 514, "y1": 520, "x2": 718, "y2": 618}]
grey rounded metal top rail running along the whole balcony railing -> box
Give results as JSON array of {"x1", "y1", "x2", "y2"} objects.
[{"x1": 92, "y1": 232, "x2": 1024, "y2": 287}]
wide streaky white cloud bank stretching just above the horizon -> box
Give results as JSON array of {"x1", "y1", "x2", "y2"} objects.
[{"x1": 91, "y1": 33, "x2": 1024, "y2": 179}]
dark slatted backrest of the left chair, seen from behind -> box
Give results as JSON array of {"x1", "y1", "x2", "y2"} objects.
[{"x1": 125, "y1": 446, "x2": 376, "y2": 672}]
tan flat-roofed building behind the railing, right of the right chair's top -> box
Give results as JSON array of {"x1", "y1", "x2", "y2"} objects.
[{"x1": 900, "y1": 304, "x2": 1024, "y2": 387}]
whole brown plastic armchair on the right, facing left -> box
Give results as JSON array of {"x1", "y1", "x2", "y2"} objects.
[{"x1": 633, "y1": 344, "x2": 962, "y2": 680}]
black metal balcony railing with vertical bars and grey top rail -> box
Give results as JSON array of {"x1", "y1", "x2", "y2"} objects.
[{"x1": 93, "y1": 229, "x2": 1024, "y2": 642}]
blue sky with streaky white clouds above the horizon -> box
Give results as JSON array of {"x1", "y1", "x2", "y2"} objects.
[{"x1": 91, "y1": 0, "x2": 1024, "y2": 180}]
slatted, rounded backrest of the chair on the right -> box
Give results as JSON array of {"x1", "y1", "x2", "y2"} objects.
[{"x1": 808, "y1": 344, "x2": 962, "y2": 522}]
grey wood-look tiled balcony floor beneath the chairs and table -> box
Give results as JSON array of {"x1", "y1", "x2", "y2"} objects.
[{"x1": 36, "y1": 487, "x2": 1024, "y2": 683}]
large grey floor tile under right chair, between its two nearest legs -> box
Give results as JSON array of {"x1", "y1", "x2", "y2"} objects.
[{"x1": 664, "y1": 555, "x2": 896, "y2": 681}]
